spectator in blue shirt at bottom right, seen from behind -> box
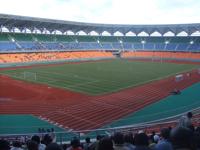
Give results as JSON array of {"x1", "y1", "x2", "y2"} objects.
[{"x1": 155, "y1": 128, "x2": 173, "y2": 150}]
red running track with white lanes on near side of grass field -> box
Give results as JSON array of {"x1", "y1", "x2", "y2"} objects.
[{"x1": 0, "y1": 64, "x2": 200, "y2": 130}]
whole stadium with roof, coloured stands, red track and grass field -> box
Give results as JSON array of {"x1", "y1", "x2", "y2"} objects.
[{"x1": 0, "y1": 4, "x2": 200, "y2": 149}]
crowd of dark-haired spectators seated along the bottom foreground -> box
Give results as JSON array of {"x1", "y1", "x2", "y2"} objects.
[{"x1": 0, "y1": 112, "x2": 200, "y2": 150}]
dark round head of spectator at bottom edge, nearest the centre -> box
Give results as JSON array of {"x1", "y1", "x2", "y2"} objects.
[{"x1": 97, "y1": 137, "x2": 114, "y2": 150}]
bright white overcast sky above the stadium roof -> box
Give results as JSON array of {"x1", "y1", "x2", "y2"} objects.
[{"x1": 0, "y1": 0, "x2": 200, "y2": 24}]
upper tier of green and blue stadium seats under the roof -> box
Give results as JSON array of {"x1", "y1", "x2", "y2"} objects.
[{"x1": 0, "y1": 33, "x2": 200, "y2": 53}]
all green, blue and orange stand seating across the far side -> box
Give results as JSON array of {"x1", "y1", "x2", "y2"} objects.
[{"x1": 0, "y1": 33, "x2": 200, "y2": 63}]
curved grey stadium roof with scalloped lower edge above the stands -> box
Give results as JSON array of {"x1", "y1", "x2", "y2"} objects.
[{"x1": 0, "y1": 14, "x2": 200, "y2": 35}]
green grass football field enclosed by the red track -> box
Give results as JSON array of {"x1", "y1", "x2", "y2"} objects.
[{"x1": 0, "y1": 60, "x2": 199, "y2": 95}]
